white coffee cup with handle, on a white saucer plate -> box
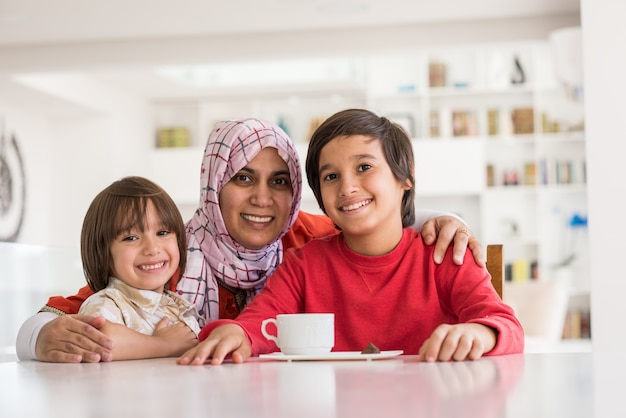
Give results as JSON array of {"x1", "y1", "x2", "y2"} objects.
[{"x1": 261, "y1": 313, "x2": 335, "y2": 355}]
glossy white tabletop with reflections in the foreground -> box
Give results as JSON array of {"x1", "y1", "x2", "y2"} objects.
[{"x1": 0, "y1": 353, "x2": 626, "y2": 418}]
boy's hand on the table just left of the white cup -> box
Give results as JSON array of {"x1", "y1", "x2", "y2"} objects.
[{"x1": 176, "y1": 324, "x2": 252, "y2": 366}]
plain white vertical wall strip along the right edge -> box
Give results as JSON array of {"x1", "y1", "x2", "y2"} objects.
[{"x1": 581, "y1": 0, "x2": 626, "y2": 352}]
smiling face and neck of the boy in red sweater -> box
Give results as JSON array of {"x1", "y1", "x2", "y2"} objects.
[{"x1": 319, "y1": 135, "x2": 409, "y2": 255}]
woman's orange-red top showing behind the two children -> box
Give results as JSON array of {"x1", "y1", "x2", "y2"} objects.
[{"x1": 42, "y1": 211, "x2": 337, "y2": 318}]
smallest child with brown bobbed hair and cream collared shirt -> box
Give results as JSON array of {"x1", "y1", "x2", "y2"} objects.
[{"x1": 79, "y1": 177, "x2": 200, "y2": 360}]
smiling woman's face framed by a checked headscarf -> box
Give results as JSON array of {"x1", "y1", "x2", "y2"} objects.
[{"x1": 219, "y1": 148, "x2": 293, "y2": 250}]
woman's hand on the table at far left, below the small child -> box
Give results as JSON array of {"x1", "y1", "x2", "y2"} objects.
[{"x1": 35, "y1": 315, "x2": 113, "y2": 363}]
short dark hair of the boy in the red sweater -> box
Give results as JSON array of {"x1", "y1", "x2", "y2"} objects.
[{"x1": 306, "y1": 109, "x2": 415, "y2": 227}]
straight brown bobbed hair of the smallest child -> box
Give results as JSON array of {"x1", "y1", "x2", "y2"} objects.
[{"x1": 80, "y1": 176, "x2": 187, "y2": 292}]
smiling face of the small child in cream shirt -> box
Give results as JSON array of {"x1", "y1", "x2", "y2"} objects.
[{"x1": 111, "y1": 202, "x2": 180, "y2": 293}]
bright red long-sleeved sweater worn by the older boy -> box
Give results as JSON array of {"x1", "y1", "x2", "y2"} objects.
[{"x1": 200, "y1": 228, "x2": 524, "y2": 355}]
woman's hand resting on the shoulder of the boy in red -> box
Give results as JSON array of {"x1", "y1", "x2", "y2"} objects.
[{"x1": 421, "y1": 216, "x2": 485, "y2": 267}]
